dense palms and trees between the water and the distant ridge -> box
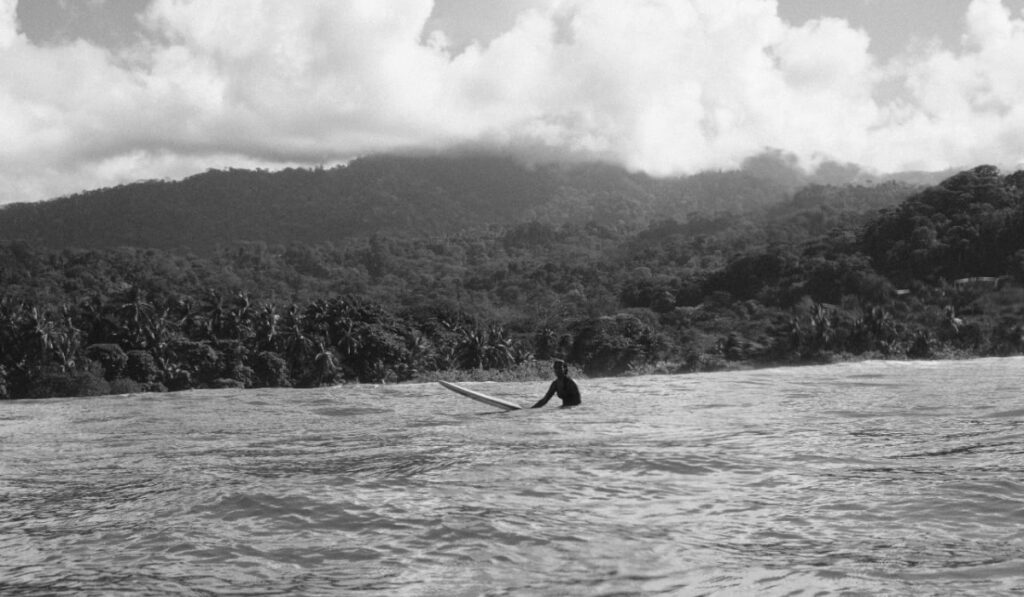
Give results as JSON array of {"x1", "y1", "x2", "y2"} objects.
[{"x1": 0, "y1": 166, "x2": 1024, "y2": 397}]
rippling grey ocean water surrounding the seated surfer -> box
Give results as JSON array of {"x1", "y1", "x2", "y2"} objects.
[{"x1": 0, "y1": 358, "x2": 1024, "y2": 596}]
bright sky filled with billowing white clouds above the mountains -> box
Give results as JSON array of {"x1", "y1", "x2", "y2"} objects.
[{"x1": 0, "y1": 0, "x2": 1024, "y2": 204}]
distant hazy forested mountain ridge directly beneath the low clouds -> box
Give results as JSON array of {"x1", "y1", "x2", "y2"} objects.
[{"x1": 0, "y1": 155, "x2": 915, "y2": 255}]
